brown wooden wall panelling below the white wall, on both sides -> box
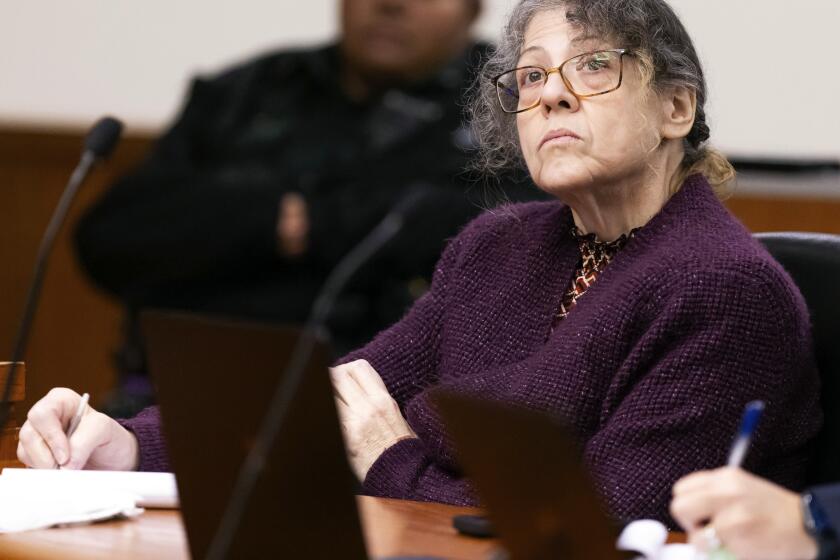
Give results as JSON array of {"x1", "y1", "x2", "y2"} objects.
[{"x1": 0, "y1": 129, "x2": 840, "y2": 424}]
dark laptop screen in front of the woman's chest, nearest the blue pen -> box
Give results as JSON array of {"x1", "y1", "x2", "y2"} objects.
[{"x1": 433, "y1": 391, "x2": 633, "y2": 560}]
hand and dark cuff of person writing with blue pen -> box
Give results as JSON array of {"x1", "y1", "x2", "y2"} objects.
[{"x1": 671, "y1": 468, "x2": 840, "y2": 560}]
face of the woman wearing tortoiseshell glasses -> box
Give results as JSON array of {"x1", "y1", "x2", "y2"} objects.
[{"x1": 517, "y1": 10, "x2": 662, "y2": 195}]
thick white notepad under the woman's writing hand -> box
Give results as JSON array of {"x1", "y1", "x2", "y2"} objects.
[{"x1": 0, "y1": 468, "x2": 178, "y2": 508}]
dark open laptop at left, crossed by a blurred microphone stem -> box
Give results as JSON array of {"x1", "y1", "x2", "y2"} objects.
[{"x1": 141, "y1": 312, "x2": 368, "y2": 560}]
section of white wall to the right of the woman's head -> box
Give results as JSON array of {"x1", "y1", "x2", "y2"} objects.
[{"x1": 671, "y1": 0, "x2": 840, "y2": 159}]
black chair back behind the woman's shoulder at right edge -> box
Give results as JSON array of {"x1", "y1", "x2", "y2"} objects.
[{"x1": 756, "y1": 232, "x2": 840, "y2": 485}]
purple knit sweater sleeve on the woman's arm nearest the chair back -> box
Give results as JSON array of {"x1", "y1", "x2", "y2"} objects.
[{"x1": 585, "y1": 267, "x2": 820, "y2": 526}]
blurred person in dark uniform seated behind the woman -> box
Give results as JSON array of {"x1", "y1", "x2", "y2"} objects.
[{"x1": 76, "y1": 0, "x2": 540, "y2": 414}]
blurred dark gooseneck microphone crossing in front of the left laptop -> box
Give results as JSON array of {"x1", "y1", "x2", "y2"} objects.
[{"x1": 205, "y1": 186, "x2": 429, "y2": 560}]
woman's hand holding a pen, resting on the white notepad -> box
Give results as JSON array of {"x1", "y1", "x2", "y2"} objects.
[{"x1": 17, "y1": 388, "x2": 140, "y2": 471}]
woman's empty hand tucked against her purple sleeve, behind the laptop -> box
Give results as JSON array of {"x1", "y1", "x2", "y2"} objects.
[{"x1": 330, "y1": 360, "x2": 417, "y2": 480}]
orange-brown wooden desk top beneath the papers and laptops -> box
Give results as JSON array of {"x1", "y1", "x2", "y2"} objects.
[{"x1": 0, "y1": 496, "x2": 497, "y2": 560}]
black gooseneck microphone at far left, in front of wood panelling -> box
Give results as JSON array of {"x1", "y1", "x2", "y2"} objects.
[{"x1": 0, "y1": 117, "x2": 123, "y2": 429}]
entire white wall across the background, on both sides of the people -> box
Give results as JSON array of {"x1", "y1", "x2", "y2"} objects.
[{"x1": 0, "y1": 0, "x2": 840, "y2": 158}]
